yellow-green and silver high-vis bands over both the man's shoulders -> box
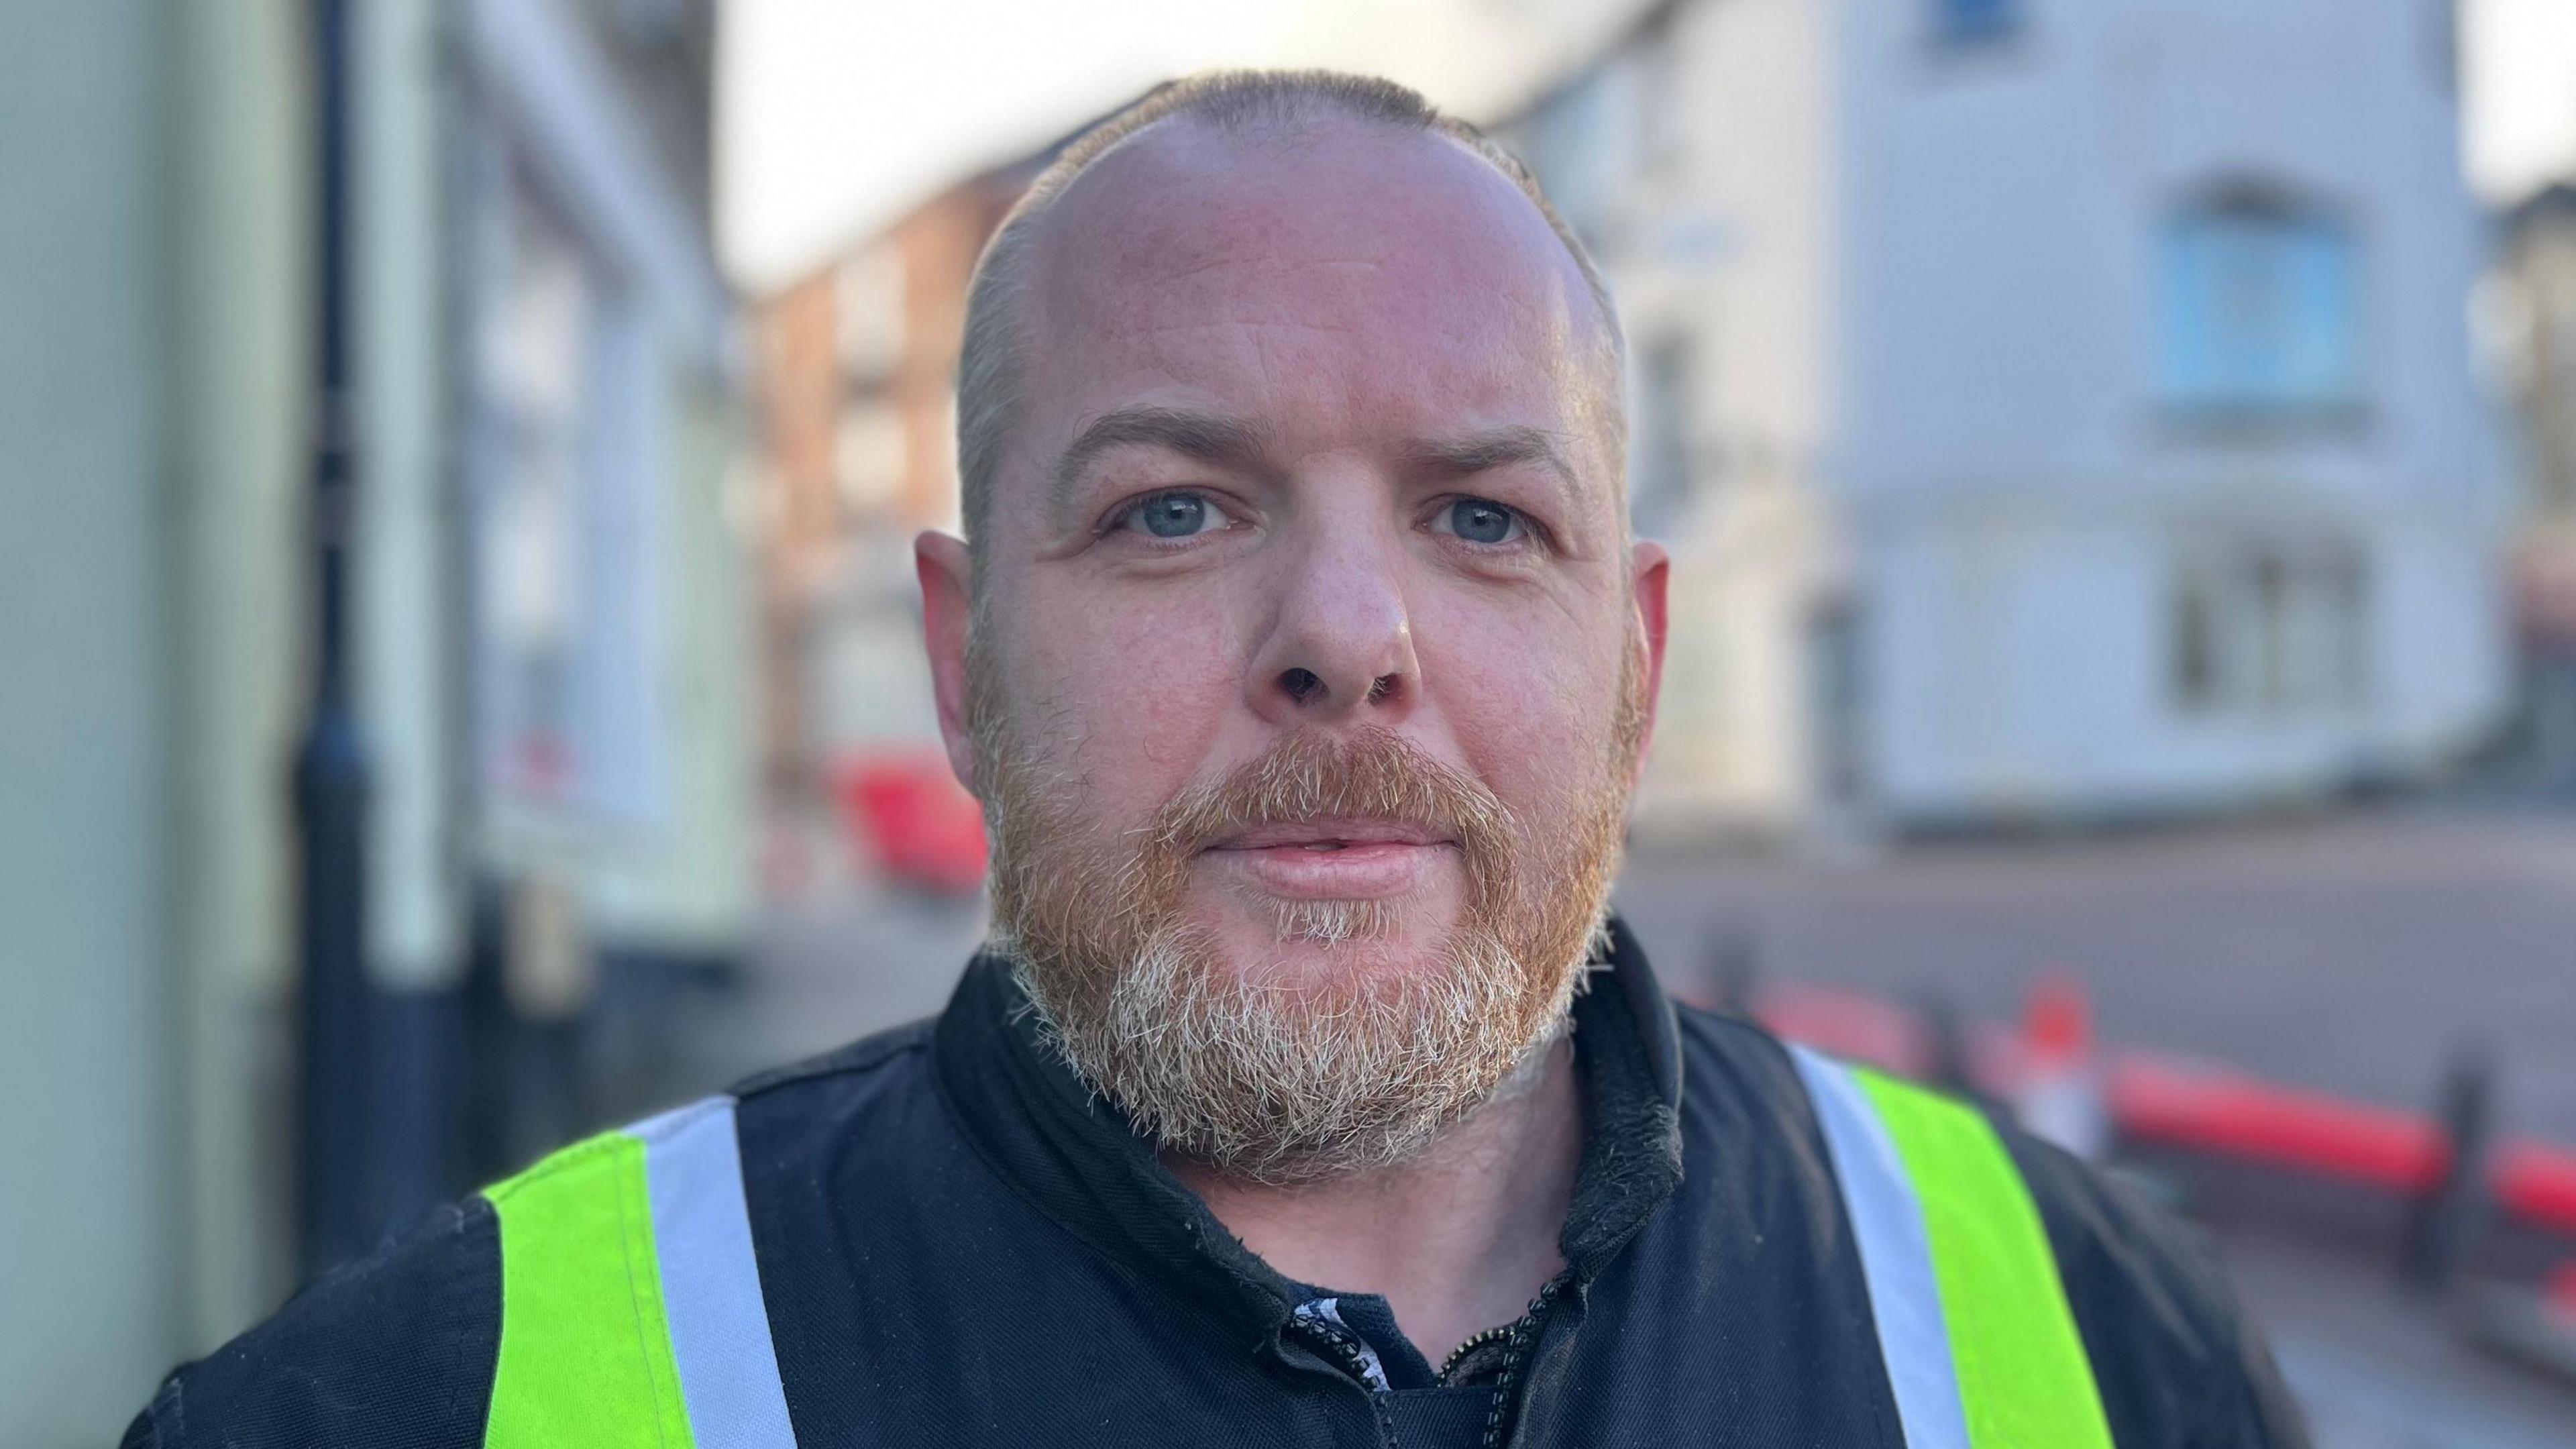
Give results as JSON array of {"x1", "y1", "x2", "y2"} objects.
[{"x1": 484, "y1": 1046, "x2": 2112, "y2": 1449}]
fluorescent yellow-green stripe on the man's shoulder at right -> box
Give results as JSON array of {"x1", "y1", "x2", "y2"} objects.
[{"x1": 1852, "y1": 1070, "x2": 2112, "y2": 1449}]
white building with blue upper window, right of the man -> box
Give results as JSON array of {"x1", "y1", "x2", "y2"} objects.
[{"x1": 1505, "y1": 0, "x2": 2506, "y2": 828}]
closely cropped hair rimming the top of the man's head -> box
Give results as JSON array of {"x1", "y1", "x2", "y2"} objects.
[{"x1": 958, "y1": 70, "x2": 1625, "y2": 546}]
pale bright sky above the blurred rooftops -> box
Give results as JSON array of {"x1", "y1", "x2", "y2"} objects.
[{"x1": 716, "y1": 0, "x2": 2576, "y2": 294}]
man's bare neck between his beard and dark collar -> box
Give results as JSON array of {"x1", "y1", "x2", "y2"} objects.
[{"x1": 1169, "y1": 1036, "x2": 1585, "y2": 1366}]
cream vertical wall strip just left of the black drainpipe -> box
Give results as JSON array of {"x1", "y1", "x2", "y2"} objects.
[{"x1": 154, "y1": 0, "x2": 312, "y2": 1372}]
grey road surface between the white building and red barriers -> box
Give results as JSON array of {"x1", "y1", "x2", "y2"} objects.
[{"x1": 1618, "y1": 812, "x2": 2576, "y2": 1144}]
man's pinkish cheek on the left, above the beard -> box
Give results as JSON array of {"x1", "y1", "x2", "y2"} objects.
[{"x1": 1012, "y1": 577, "x2": 1242, "y2": 815}]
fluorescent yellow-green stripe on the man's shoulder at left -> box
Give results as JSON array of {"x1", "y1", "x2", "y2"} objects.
[{"x1": 484, "y1": 1132, "x2": 693, "y2": 1449}]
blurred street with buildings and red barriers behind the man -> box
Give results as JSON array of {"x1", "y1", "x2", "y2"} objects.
[{"x1": 0, "y1": 0, "x2": 2576, "y2": 1449}]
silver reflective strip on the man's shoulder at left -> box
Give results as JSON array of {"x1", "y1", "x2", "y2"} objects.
[{"x1": 629, "y1": 1095, "x2": 796, "y2": 1449}]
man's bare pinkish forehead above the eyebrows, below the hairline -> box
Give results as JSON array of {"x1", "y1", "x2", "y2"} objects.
[{"x1": 1022, "y1": 119, "x2": 1602, "y2": 479}]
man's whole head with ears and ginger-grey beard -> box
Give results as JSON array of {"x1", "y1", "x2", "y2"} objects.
[{"x1": 914, "y1": 74, "x2": 1669, "y2": 1150}]
